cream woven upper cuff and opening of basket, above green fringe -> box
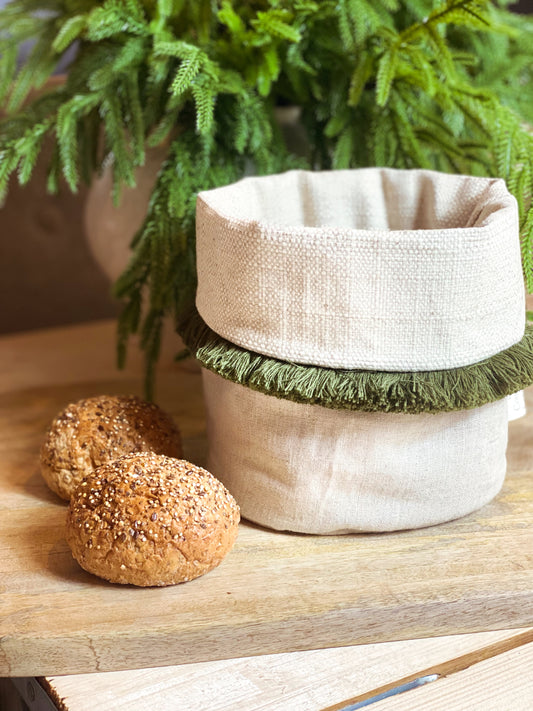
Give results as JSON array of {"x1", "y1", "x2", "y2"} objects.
[{"x1": 196, "y1": 168, "x2": 525, "y2": 371}]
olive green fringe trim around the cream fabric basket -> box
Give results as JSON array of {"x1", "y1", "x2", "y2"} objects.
[{"x1": 178, "y1": 310, "x2": 533, "y2": 414}]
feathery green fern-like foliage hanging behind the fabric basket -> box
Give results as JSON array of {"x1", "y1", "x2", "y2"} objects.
[{"x1": 0, "y1": 0, "x2": 533, "y2": 392}]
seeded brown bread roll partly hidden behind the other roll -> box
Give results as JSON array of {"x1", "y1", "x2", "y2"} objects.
[{"x1": 41, "y1": 395, "x2": 182, "y2": 500}]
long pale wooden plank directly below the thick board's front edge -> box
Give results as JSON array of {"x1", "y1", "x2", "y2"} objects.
[{"x1": 40, "y1": 631, "x2": 533, "y2": 711}]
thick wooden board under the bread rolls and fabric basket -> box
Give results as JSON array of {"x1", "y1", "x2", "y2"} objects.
[{"x1": 0, "y1": 324, "x2": 533, "y2": 676}]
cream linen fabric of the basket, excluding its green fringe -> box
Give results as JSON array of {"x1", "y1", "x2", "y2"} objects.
[{"x1": 187, "y1": 168, "x2": 530, "y2": 534}]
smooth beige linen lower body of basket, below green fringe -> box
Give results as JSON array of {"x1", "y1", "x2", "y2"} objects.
[{"x1": 202, "y1": 369, "x2": 508, "y2": 534}]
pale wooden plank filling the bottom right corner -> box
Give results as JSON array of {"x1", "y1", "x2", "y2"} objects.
[{"x1": 371, "y1": 644, "x2": 533, "y2": 711}]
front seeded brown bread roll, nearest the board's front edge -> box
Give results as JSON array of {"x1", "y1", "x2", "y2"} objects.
[{"x1": 66, "y1": 452, "x2": 240, "y2": 587}]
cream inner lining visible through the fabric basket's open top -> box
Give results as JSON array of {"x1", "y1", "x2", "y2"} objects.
[{"x1": 204, "y1": 168, "x2": 513, "y2": 231}]
